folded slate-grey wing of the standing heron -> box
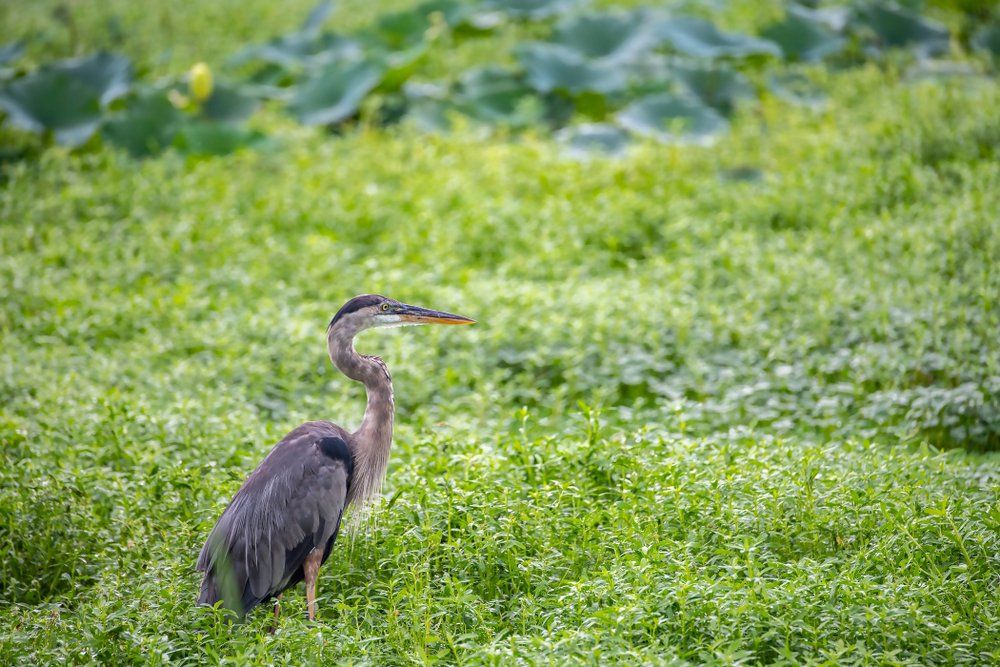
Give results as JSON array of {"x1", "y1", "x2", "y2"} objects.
[{"x1": 198, "y1": 422, "x2": 353, "y2": 614}]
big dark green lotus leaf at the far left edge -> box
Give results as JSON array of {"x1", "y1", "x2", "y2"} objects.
[{"x1": 0, "y1": 67, "x2": 101, "y2": 146}]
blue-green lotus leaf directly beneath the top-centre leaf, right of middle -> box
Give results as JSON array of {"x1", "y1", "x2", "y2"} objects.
[{"x1": 517, "y1": 42, "x2": 627, "y2": 94}]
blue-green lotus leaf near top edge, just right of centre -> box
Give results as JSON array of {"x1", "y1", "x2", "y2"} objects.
[{"x1": 551, "y1": 12, "x2": 656, "y2": 63}]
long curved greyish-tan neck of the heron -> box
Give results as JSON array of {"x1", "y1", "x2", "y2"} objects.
[{"x1": 327, "y1": 327, "x2": 394, "y2": 505}]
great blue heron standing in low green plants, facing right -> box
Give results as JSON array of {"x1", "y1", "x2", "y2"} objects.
[{"x1": 198, "y1": 294, "x2": 474, "y2": 620}]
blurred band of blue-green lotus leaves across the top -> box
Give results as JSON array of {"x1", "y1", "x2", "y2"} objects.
[{"x1": 0, "y1": 0, "x2": 1000, "y2": 156}]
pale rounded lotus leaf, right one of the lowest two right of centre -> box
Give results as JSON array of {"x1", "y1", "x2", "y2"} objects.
[{"x1": 617, "y1": 93, "x2": 729, "y2": 143}]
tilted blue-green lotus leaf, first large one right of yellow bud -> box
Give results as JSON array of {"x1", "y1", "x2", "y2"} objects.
[{"x1": 289, "y1": 60, "x2": 383, "y2": 125}]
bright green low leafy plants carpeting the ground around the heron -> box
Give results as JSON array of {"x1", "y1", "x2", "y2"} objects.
[{"x1": 0, "y1": 0, "x2": 1000, "y2": 665}]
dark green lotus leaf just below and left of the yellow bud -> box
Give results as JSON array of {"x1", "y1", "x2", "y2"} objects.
[{"x1": 101, "y1": 91, "x2": 184, "y2": 157}]
